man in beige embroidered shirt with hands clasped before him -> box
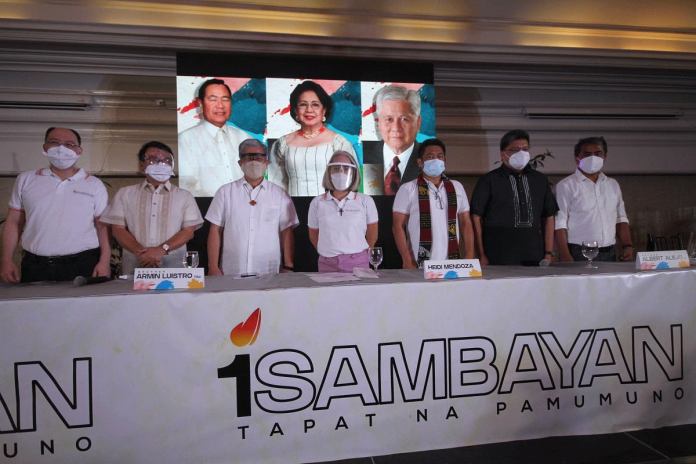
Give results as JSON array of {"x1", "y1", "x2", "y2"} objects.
[{"x1": 100, "y1": 141, "x2": 203, "y2": 274}]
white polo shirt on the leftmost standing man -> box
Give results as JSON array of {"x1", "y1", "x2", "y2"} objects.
[{"x1": 9, "y1": 168, "x2": 109, "y2": 256}]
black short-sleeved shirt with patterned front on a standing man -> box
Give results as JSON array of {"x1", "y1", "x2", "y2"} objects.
[{"x1": 471, "y1": 165, "x2": 558, "y2": 264}]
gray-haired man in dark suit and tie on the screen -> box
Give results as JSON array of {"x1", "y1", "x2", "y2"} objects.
[{"x1": 363, "y1": 85, "x2": 421, "y2": 195}]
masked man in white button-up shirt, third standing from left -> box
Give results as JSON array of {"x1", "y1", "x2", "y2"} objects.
[{"x1": 205, "y1": 139, "x2": 299, "y2": 276}]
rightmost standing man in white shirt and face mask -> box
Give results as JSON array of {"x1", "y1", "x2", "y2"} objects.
[{"x1": 556, "y1": 137, "x2": 633, "y2": 261}]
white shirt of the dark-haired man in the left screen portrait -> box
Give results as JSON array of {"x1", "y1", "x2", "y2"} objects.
[{"x1": 179, "y1": 121, "x2": 251, "y2": 197}]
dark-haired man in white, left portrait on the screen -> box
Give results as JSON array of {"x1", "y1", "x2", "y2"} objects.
[{"x1": 179, "y1": 79, "x2": 249, "y2": 197}]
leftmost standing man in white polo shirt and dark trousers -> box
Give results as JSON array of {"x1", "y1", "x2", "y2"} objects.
[{"x1": 0, "y1": 127, "x2": 111, "y2": 282}]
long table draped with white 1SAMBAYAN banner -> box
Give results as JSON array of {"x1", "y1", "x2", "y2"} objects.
[{"x1": 0, "y1": 263, "x2": 696, "y2": 464}]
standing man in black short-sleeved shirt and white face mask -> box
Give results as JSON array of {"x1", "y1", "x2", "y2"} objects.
[{"x1": 471, "y1": 130, "x2": 558, "y2": 265}]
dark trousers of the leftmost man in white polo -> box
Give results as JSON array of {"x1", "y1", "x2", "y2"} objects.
[{"x1": 22, "y1": 248, "x2": 101, "y2": 282}]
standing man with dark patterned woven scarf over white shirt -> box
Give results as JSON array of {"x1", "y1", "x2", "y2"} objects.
[{"x1": 392, "y1": 139, "x2": 474, "y2": 269}]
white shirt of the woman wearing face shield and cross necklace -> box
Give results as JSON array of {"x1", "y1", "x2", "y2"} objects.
[{"x1": 307, "y1": 192, "x2": 378, "y2": 258}]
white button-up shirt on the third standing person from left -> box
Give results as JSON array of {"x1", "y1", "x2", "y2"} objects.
[{"x1": 205, "y1": 178, "x2": 300, "y2": 275}]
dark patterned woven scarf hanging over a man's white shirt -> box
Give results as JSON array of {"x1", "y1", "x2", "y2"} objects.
[{"x1": 418, "y1": 174, "x2": 460, "y2": 266}]
